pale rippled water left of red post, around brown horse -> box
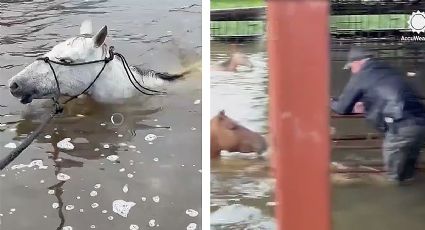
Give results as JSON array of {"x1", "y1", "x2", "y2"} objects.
[{"x1": 210, "y1": 41, "x2": 276, "y2": 229}]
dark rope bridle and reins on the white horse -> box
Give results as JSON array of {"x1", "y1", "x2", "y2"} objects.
[{"x1": 36, "y1": 46, "x2": 166, "y2": 113}]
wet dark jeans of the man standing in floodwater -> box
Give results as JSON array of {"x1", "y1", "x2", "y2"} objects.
[{"x1": 383, "y1": 125, "x2": 425, "y2": 181}]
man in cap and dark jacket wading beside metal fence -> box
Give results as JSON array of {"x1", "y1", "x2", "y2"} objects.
[{"x1": 331, "y1": 47, "x2": 425, "y2": 183}]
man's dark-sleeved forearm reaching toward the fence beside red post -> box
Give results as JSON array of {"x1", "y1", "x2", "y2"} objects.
[{"x1": 331, "y1": 76, "x2": 363, "y2": 114}]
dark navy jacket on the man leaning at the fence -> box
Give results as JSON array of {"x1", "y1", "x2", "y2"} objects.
[{"x1": 331, "y1": 59, "x2": 425, "y2": 132}]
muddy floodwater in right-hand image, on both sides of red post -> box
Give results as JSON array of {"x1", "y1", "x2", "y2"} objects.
[{"x1": 210, "y1": 41, "x2": 425, "y2": 230}]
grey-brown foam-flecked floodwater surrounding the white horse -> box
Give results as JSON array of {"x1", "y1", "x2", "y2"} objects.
[{"x1": 0, "y1": 0, "x2": 202, "y2": 230}]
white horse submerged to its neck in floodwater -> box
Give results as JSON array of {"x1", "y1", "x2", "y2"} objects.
[{"x1": 9, "y1": 22, "x2": 182, "y2": 104}]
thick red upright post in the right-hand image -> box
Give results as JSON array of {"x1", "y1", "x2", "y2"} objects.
[{"x1": 267, "y1": 0, "x2": 331, "y2": 230}]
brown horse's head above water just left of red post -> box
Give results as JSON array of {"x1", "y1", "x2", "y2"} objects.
[{"x1": 210, "y1": 111, "x2": 267, "y2": 158}]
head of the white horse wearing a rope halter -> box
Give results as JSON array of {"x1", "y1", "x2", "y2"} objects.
[{"x1": 9, "y1": 23, "x2": 107, "y2": 104}]
